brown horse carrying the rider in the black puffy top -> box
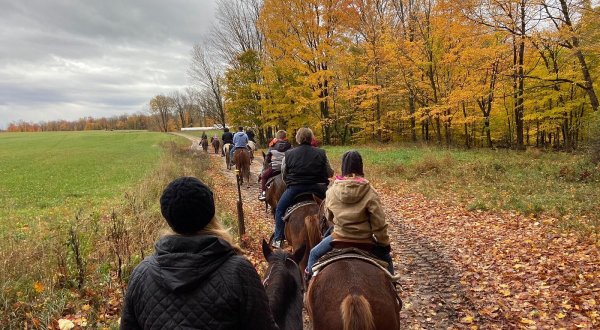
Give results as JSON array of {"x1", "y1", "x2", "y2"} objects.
[{"x1": 284, "y1": 199, "x2": 321, "y2": 269}]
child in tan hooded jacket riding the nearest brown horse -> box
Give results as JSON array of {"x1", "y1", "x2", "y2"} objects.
[{"x1": 305, "y1": 150, "x2": 394, "y2": 277}]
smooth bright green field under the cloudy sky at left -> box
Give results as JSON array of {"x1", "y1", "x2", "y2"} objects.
[{"x1": 0, "y1": 131, "x2": 181, "y2": 233}]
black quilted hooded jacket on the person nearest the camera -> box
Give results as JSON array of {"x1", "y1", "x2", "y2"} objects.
[{"x1": 121, "y1": 235, "x2": 277, "y2": 329}]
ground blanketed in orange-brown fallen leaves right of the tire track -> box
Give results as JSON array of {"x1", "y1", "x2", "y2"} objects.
[{"x1": 380, "y1": 190, "x2": 600, "y2": 329}]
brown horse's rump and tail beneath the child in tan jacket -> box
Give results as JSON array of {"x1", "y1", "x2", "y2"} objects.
[{"x1": 306, "y1": 259, "x2": 402, "y2": 330}]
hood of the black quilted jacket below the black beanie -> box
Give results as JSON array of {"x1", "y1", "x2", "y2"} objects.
[{"x1": 150, "y1": 235, "x2": 235, "y2": 291}]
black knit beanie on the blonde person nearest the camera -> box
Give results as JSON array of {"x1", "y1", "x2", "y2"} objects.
[{"x1": 160, "y1": 176, "x2": 215, "y2": 234}]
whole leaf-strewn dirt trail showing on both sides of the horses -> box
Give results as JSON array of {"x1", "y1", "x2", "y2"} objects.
[{"x1": 179, "y1": 134, "x2": 479, "y2": 329}]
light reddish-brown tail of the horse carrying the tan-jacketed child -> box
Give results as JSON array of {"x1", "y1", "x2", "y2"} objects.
[{"x1": 340, "y1": 294, "x2": 375, "y2": 330}]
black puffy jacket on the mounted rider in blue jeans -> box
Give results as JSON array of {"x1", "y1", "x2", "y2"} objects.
[{"x1": 283, "y1": 144, "x2": 333, "y2": 187}]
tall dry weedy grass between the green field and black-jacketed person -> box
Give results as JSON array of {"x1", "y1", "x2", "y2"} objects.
[{"x1": 0, "y1": 135, "x2": 209, "y2": 329}]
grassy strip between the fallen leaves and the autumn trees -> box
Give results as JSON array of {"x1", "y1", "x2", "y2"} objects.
[{"x1": 326, "y1": 146, "x2": 600, "y2": 225}]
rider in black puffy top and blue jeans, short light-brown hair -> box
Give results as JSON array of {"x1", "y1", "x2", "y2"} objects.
[{"x1": 273, "y1": 127, "x2": 333, "y2": 247}]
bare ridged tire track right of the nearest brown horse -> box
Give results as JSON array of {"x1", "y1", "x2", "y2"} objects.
[{"x1": 381, "y1": 196, "x2": 477, "y2": 329}]
